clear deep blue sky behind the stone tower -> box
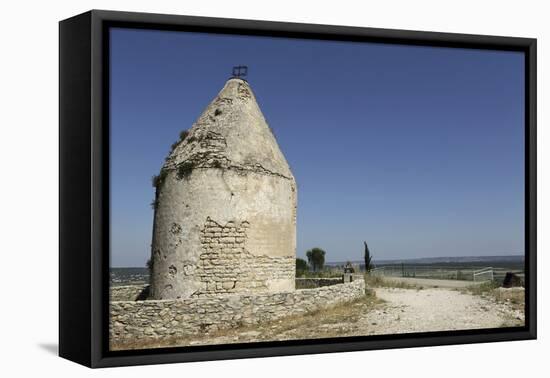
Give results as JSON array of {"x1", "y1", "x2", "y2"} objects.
[{"x1": 111, "y1": 29, "x2": 524, "y2": 266}]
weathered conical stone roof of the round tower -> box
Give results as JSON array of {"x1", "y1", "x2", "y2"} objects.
[{"x1": 163, "y1": 78, "x2": 293, "y2": 179}]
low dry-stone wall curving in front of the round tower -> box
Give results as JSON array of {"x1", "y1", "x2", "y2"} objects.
[{"x1": 109, "y1": 280, "x2": 365, "y2": 343}]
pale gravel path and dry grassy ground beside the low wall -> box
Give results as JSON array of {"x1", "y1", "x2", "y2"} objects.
[{"x1": 113, "y1": 287, "x2": 525, "y2": 348}]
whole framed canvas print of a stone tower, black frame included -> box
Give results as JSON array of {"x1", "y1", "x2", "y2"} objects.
[{"x1": 59, "y1": 10, "x2": 536, "y2": 367}]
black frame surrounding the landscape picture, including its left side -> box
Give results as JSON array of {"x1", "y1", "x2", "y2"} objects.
[{"x1": 59, "y1": 10, "x2": 537, "y2": 367}]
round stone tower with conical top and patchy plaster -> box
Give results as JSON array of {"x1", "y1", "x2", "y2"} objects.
[{"x1": 151, "y1": 71, "x2": 297, "y2": 299}]
